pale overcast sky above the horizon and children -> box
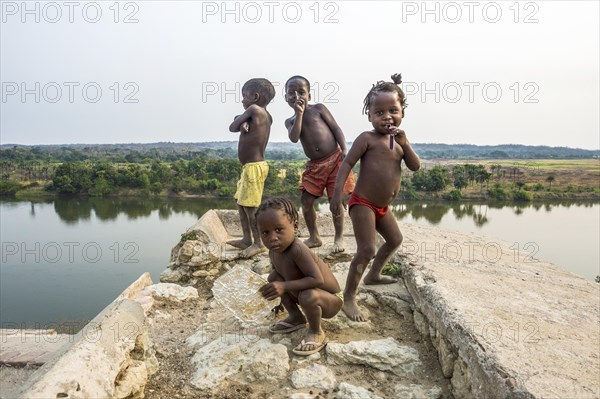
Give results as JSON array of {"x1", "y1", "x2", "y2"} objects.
[{"x1": 0, "y1": 1, "x2": 600, "y2": 149}]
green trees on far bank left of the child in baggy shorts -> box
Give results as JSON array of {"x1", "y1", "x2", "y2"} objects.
[{"x1": 0, "y1": 157, "x2": 301, "y2": 197}]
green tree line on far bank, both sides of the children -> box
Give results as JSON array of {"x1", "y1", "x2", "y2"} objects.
[{"x1": 0, "y1": 157, "x2": 576, "y2": 201}]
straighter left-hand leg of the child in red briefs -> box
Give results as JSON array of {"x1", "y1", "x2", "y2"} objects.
[{"x1": 342, "y1": 205, "x2": 375, "y2": 321}]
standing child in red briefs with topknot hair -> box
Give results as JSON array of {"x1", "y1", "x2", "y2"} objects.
[{"x1": 330, "y1": 74, "x2": 421, "y2": 321}]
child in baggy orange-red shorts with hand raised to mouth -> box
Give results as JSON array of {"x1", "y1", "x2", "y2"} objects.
[{"x1": 285, "y1": 76, "x2": 354, "y2": 253}]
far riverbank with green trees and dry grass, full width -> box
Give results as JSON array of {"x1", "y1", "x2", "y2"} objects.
[{"x1": 0, "y1": 158, "x2": 600, "y2": 202}]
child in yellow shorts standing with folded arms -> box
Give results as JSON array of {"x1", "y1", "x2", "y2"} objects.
[{"x1": 227, "y1": 78, "x2": 275, "y2": 258}]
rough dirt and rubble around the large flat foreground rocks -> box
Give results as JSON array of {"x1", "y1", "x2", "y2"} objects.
[{"x1": 145, "y1": 248, "x2": 451, "y2": 399}]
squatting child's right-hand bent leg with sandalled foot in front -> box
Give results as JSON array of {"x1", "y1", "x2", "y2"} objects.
[{"x1": 296, "y1": 288, "x2": 342, "y2": 351}]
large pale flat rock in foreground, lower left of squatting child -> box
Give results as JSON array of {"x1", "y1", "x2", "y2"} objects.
[{"x1": 190, "y1": 334, "x2": 290, "y2": 389}]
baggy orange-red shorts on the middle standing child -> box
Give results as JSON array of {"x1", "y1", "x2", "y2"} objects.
[{"x1": 300, "y1": 147, "x2": 354, "y2": 198}]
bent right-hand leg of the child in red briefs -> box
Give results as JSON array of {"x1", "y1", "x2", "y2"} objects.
[{"x1": 364, "y1": 211, "x2": 402, "y2": 284}]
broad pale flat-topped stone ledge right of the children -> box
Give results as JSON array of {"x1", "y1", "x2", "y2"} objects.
[{"x1": 398, "y1": 223, "x2": 600, "y2": 399}]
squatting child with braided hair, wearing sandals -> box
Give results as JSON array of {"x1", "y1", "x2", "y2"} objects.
[{"x1": 256, "y1": 197, "x2": 343, "y2": 356}]
